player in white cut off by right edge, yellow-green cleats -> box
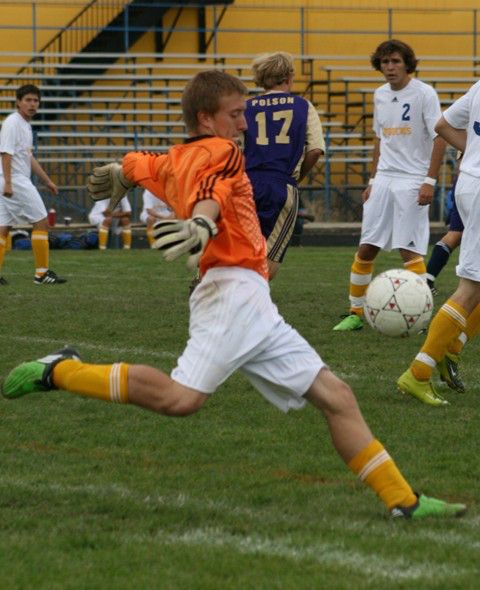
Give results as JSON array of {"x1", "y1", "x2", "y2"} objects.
[{"x1": 397, "y1": 82, "x2": 480, "y2": 406}]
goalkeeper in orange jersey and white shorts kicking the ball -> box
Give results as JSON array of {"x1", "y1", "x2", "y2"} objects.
[{"x1": 2, "y1": 70, "x2": 466, "y2": 519}]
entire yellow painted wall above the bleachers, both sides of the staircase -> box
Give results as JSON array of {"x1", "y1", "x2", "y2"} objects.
[{"x1": 0, "y1": 0, "x2": 480, "y2": 56}]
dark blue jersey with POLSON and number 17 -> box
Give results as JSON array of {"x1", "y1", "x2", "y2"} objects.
[{"x1": 244, "y1": 92, "x2": 309, "y2": 184}]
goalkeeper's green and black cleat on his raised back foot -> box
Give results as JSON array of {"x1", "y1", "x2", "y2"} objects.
[{"x1": 2, "y1": 347, "x2": 80, "y2": 399}]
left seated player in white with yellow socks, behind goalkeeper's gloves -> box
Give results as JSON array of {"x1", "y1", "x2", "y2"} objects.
[{"x1": 88, "y1": 197, "x2": 132, "y2": 250}]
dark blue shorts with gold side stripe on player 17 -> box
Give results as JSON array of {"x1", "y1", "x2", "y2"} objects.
[{"x1": 250, "y1": 173, "x2": 298, "y2": 262}]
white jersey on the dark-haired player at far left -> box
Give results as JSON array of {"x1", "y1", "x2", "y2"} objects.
[{"x1": 0, "y1": 112, "x2": 33, "y2": 178}]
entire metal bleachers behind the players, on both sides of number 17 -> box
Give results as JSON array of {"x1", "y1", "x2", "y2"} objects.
[{"x1": 0, "y1": 53, "x2": 466, "y2": 221}]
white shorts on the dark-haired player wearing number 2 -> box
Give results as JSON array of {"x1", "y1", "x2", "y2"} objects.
[{"x1": 360, "y1": 173, "x2": 430, "y2": 256}]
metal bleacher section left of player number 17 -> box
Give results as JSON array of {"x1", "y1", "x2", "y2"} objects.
[{"x1": 0, "y1": 54, "x2": 255, "y2": 218}]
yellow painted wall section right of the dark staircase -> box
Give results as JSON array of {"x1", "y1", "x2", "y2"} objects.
[{"x1": 218, "y1": 0, "x2": 480, "y2": 56}]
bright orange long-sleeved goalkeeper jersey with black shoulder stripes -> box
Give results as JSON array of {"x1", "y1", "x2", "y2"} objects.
[{"x1": 123, "y1": 136, "x2": 268, "y2": 278}]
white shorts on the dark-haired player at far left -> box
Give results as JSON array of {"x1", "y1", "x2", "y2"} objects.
[{"x1": 0, "y1": 175, "x2": 47, "y2": 226}]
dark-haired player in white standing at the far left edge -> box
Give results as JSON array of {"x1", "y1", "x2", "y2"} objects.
[{"x1": 0, "y1": 84, "x2": 66, "y2": 285}]
